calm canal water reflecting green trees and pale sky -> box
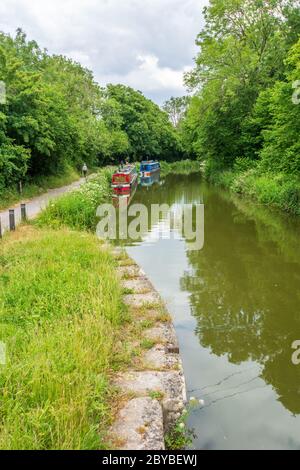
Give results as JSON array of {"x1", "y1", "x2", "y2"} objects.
[{"x1": 117, "y1": 175, "x2": 300, "y2": 449}]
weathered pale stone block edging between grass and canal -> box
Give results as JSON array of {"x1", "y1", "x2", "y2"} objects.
[{"x1": 110, "y1": 250, "x2": 187, "y2": 450}]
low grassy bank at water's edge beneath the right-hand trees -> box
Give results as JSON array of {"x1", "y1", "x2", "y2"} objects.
[{"x1": 205, "y1": 165, "x2": 300, "y2": 215}]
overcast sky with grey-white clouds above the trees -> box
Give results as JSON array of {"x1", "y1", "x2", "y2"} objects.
[{"x1": 0, "y1": 0, "x2": 208, "y2": 104}]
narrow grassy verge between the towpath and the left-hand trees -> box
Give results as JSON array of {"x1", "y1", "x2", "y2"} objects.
[{"x1": 0, "y1": 167, "x2": 80, "y2": 210}]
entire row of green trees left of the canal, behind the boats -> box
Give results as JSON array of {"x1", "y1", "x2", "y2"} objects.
[{"x1": 0, "y1": 30, "x2": 181, "y2": 192}]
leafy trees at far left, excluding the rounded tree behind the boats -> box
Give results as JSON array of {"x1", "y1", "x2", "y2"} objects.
[{"x1": 0, "y1": 31, "x2": 105, "y2": 186}]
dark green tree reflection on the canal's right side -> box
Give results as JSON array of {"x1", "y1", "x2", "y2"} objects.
[{"x1": 181, "y1": 185, "x2": 300, "y2": 414}]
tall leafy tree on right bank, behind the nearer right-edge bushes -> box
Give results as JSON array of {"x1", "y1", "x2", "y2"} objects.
[{"x1": 183, "y1": 0, "x2": 299, "y2": 169}]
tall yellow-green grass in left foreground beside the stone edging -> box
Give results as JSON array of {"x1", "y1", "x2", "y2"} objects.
[{"x1": 0, "y1": 227, "x2": 122, "y2": 449}]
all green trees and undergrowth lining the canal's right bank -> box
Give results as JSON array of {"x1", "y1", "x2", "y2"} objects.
[{"x1": 181, "y1": 0, "x2": 300, "y2": 212}]
